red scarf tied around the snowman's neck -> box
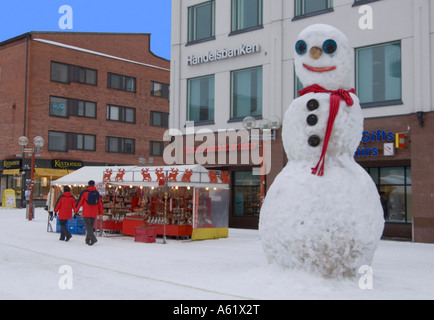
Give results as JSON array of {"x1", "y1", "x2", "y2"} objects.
[{"x1": 298, "y1": 84, "x2": 356, "y2": 176}]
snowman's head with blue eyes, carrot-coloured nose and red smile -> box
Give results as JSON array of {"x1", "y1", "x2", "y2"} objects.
[{"x1": 294, "y1": 24, "x2": 354, "y2": 90}]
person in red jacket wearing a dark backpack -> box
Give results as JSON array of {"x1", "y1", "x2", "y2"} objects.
[{"x1": 75, "y1": 180, "x2": 103, "y2": 246}]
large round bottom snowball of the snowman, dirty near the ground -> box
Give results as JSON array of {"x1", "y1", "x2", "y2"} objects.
[{"x1": 259, "y1": 159, "x2": 384, "y2": 278}]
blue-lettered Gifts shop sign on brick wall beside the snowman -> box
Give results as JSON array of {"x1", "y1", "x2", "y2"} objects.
[{"x1": 354, "y1": 129, "x2": 395, "y2": 157}]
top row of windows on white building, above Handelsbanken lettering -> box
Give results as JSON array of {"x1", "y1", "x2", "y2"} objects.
[{"x1": 187, "y1": 0, "x2": 378, "y2": 44}]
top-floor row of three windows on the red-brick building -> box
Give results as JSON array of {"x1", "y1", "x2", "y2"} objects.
[{"x1": 50, "y1": 61, "x2": 169, "y2": 99}]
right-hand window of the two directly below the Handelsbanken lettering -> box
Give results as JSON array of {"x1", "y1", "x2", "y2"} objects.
[{"x1": 231, "y1": 67, "x2": 262, "y2": 118}]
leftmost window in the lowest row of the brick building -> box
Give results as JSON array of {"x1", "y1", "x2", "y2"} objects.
[{"x1": 48, "y1": 131, "x2": 96, "y2": 152}]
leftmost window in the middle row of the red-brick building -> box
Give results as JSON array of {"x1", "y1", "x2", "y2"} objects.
[{"x1": 50, "y1": 97, "x2": 96, "y2": 118}]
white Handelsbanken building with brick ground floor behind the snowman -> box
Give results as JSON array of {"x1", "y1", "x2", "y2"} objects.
[{"x1": 169, "y1": 0, "x2": 434, "y2": 242}]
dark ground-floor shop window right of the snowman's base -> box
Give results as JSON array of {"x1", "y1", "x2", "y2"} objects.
[{"x1": 366, "y1": 167, "x2": 412, "y2": 223}]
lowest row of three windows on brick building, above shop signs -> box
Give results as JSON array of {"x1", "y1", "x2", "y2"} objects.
[{"x1": 48, "y1": 131, "x2": 164, "y2": 156}]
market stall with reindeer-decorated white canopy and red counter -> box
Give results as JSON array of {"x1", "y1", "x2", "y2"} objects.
[{"x1": 52, "y1": 165, "x2": 229, "y2": 240}]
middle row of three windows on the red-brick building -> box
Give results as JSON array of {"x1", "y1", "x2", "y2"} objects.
[{"x1": 50, "y1": 96, "x2": 169, "y2": 128}]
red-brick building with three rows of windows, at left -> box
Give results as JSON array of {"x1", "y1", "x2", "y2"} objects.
[{"x1": 0, "y1": 32, "x2": 170, "y2": 208}]
